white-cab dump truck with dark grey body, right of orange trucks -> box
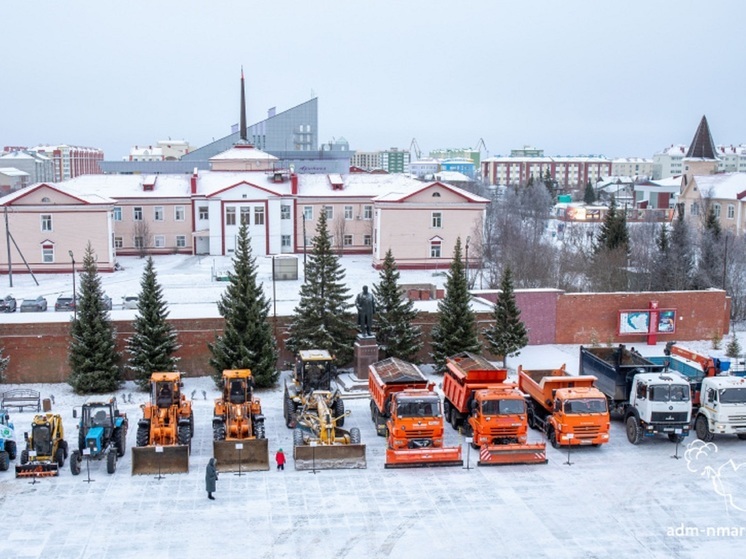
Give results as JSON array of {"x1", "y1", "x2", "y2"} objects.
[{"x1": 579, "y1": 344, "x2": 692, "y2": 444}]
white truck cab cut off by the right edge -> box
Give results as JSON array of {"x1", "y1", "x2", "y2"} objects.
[{"x1": 694, "y1": 376, "x2": 746, "y2": 442}]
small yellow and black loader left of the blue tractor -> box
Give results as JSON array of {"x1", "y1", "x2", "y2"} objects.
[{"x1": 16, "y1": 413, "x2": 67, "y2": 477}]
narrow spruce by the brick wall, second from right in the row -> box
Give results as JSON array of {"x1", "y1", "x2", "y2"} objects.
[{"x1": 430, "y1": 237, "x2": 482, "y2": 371}]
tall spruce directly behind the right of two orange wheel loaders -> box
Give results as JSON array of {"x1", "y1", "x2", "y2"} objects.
[{"x1": 209, "y1": 224, "x2": 280, "y2": 388}]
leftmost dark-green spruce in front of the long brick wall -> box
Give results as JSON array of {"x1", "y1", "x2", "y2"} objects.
[{"x1": 67, "y1": 242, "x2": 122, "y2": 394}]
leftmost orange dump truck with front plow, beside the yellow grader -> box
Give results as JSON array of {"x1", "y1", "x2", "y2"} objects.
[{"x1": 368, "y1": 357, "x2": 464, "y2": 468}]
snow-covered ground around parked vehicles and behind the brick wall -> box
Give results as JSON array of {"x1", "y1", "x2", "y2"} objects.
[{"x1": 0, "y1": 257, "x2": 746, "y2": 559}]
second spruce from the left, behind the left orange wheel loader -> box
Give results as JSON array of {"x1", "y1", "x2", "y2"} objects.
[{"x1": 127, "y1": 256, "x2": 181, "y2": 390}]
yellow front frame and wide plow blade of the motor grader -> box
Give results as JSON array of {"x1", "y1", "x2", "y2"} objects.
[{"x1": 293, "y1": 390, "x2": 367, "y2": 470}]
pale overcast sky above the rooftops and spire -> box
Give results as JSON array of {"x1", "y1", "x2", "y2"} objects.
[{"x1": 0, "y1": 0, "x2": 746, "y2": 160}]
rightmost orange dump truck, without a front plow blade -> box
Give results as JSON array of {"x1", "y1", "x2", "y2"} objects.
[{"x1": 518, "y1": 364, "x2": 610, "y2": 448}]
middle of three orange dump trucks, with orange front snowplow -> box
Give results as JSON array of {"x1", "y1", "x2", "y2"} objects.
[{"x1": 443, "y1": 352, "x2": 547, "y2": 466}]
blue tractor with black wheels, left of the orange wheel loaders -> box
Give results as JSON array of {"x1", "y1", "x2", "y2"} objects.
[{"x1": 70, "y1": 398, "x2": 128, "y2": 476}]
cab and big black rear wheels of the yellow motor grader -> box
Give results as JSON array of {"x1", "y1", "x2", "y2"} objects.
[{"x1": 282, "y1": 349, "x2": 346, "y2": 429}]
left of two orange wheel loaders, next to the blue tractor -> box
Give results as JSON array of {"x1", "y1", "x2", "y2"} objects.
[{"x1": 132, "y1": 372, "x2": 194, "y2": 475}]
